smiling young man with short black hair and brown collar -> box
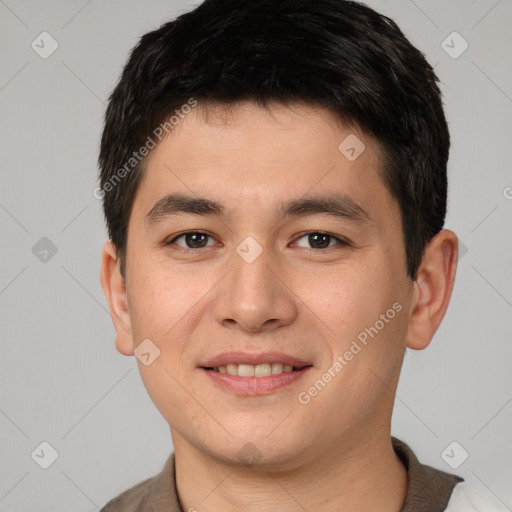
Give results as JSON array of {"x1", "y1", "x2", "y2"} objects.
[{"x1": 97, "y1": 0, "x2": 500, "y2": 512}]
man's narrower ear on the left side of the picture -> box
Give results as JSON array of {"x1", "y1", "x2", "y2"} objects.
[{"x1": 100, "y1": 241, "x2": 135, "y2": 356}]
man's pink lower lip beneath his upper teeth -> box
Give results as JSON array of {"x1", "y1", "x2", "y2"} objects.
[{"x1": 201, "y1": 366, "x2": 311, "y2": 396}]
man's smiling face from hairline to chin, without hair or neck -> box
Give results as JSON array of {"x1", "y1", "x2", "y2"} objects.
[{"x1": 102, "y1": 102, "x2": 413, "y2": 467}]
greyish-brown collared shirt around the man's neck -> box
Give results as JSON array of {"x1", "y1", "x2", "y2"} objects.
[{"x1": 100, "y1": 437, "x2": 463, "y2": 512}]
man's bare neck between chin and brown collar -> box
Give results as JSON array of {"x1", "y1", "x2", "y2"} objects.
[{"x1": 173, "y1": 429, "x2": 407, "y2": 512}]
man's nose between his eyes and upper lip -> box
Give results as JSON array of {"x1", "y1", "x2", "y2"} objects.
[{"x1": 213, "y1": 242, "x2": 298, "y2": 332}]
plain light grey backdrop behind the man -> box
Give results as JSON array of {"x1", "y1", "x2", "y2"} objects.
[{"x1": 0, "y1": 0, "x2": 512, "y2": 512}]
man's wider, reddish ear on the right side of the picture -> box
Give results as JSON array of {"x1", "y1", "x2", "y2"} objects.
[{"x1": 406, "y1": 229, "x2": 459, "y2": 350}]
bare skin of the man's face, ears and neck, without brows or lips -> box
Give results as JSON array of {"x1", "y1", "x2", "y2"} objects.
[{"x1": 101, "y1": 98, "x2": 457, "y2": 512}]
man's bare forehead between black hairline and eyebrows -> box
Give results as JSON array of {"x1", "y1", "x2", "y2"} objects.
[{"x1": 132, "y1": 102, "x2": 397, "y2": 227}]
